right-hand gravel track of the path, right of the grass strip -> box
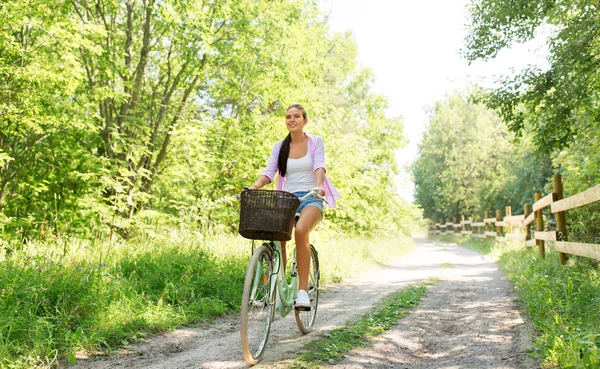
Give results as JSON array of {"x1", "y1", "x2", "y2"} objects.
[{"x1": 331, "y1": 237, "x2": 539, "y2": 369}]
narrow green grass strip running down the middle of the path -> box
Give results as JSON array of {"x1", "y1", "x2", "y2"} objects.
[{"x1": 276, "y1": 281, "x2": 432, "y2": 369}]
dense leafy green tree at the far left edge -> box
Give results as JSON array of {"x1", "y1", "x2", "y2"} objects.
[{"x1": 0, "y1": 0, "x2": 95, "y2": 230}]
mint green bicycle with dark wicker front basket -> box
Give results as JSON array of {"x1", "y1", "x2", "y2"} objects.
[{"x1": 238, "y1": 190, "x2": 325, "y2": 365}]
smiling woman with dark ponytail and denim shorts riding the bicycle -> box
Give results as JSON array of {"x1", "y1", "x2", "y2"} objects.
[{"x1": 249, "y1": 104, "x2": 340, "y2": 310}]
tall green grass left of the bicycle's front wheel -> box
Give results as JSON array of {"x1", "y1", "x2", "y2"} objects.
[{"x1": 0, "y1": 237, "x2": 246, "y2": 365}]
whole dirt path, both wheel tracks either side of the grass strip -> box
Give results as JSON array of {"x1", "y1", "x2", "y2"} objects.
[{"x1": 76, "y1": 240, "x2": 538, "y2": 369}]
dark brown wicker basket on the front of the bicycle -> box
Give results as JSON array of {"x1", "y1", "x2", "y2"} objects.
[{"x1": 238, "y1": 190, "x2": 300, "y2": 241}]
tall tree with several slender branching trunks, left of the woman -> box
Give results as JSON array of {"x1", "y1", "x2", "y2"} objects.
[{"x1": 72, "y1": 0, "x2": 318, "y2": 217}]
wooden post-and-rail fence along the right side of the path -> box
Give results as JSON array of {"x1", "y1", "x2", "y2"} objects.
[{"x1": 430, "y1": 175, "x2": 600, "y2": 264}]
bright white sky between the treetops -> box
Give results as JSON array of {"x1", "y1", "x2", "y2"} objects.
[{"x1": 322, "y1": 0, "x2": 547, "y2": 201}]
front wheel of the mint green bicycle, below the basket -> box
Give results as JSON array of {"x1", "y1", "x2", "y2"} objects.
[{"x1": 240, "y1": 244, "x2": 275, "y2": 365}]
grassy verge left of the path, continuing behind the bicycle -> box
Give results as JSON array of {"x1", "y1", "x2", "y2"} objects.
[{"x1": 0, "y1": 231, "x2": 412, "y2": 369}]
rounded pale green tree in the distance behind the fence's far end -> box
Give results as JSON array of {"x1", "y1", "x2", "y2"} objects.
[{"x1": 412, "y1": 89, "x2": 511, "y2": 221}]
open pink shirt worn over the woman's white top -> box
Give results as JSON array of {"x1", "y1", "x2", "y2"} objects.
[{"x1": 262, "y1": 133, "x2": 340, "y2": 208}]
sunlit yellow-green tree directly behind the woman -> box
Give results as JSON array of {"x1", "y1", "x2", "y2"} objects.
[{"x1": 155, "y1": 17, "x2": 413, "y2": 233}]
